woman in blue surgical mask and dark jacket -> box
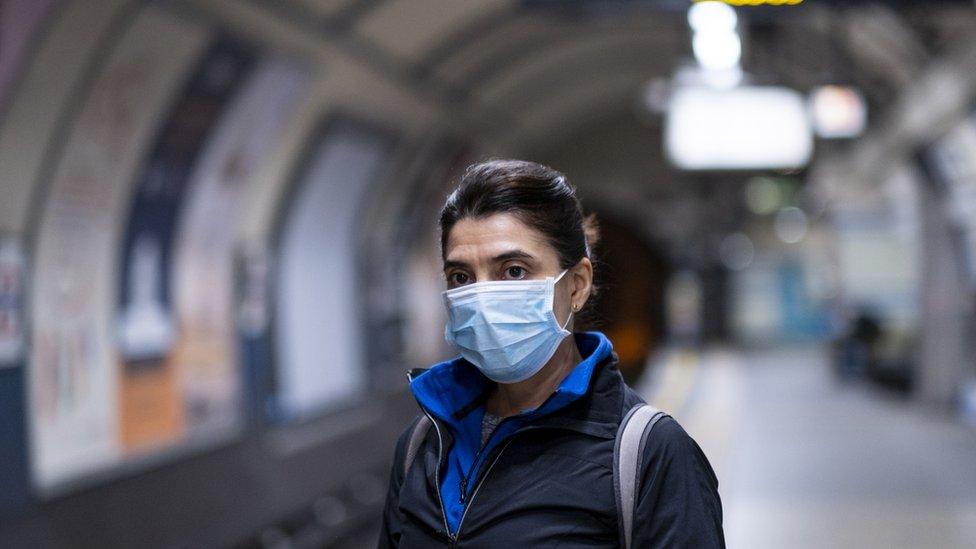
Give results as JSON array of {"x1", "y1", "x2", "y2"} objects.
[{"x1": 379, "y1": 160, "x2": 725, "y2": 548}]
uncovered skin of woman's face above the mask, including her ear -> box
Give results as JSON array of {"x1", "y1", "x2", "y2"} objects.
[{"x1": 444, "y1": 213, "x2": 593, "y2": 322}]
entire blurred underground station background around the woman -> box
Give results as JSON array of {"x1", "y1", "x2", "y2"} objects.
[{"x1": 0, "y1": 0, "x2": 976, "y2": 548}]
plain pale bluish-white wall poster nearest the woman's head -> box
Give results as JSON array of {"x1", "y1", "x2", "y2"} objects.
[{"x1": 272, "y1": 117, "x2": 393, "y2": 420}]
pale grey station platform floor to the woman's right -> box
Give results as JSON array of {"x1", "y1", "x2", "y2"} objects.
[{"x1": 640, "y1": 345, "x2": 976, "y2": 548}]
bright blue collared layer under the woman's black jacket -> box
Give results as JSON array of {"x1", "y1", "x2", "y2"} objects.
[{"x1": 410, "y1": 332, "x2": 613, "y2": 533}]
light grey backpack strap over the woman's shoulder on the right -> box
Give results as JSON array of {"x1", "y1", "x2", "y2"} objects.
[{"x1": 613, "y1": 403, "x2": 667, "y2": 549}]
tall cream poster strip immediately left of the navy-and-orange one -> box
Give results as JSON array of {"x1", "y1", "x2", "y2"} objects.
[{"x1": 27, "y1": 9, "x2": 207, "y2": 492}]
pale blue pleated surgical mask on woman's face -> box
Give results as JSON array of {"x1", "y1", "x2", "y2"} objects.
[{"x1": 443, "y1": 269, "x2": 573, "y2": 383}]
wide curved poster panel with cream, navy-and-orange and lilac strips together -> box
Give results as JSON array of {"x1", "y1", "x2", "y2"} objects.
[{"x1": 28, "y1": 6, "x2": 310, "y2": 494}]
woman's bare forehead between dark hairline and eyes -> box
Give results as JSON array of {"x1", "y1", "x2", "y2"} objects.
[{"x1": 444, "y1": 213, "x2": 557, "y2": 263}]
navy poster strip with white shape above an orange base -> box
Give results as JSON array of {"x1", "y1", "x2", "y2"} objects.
[{"x1": 116, "y1": 38, "x2": 254, "y2": 452}]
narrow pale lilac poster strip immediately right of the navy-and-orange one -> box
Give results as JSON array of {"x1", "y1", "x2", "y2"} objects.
[{"x1": 169, "y1": 57, "x2": 310, "y2": 437}]
